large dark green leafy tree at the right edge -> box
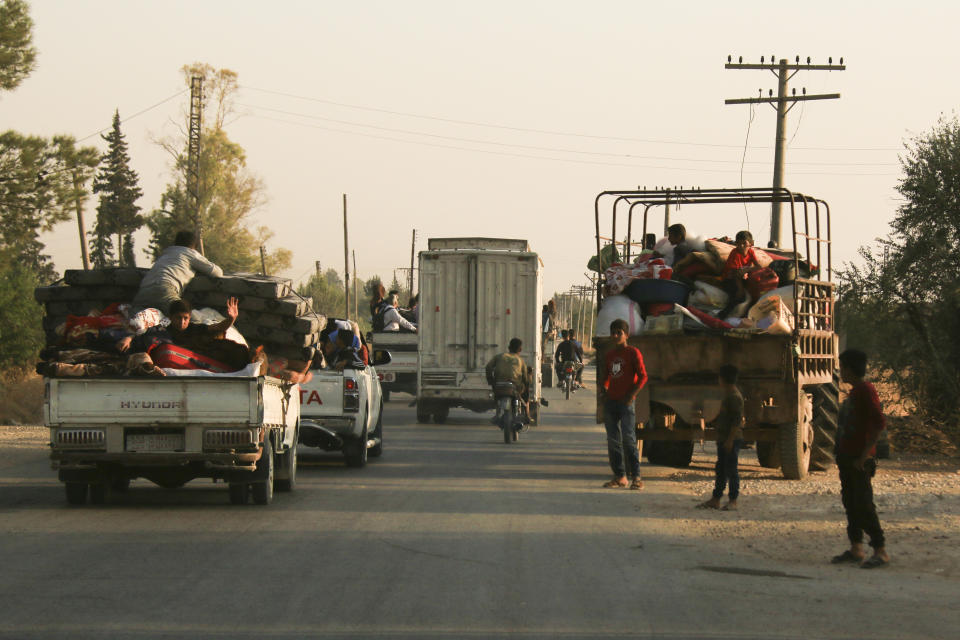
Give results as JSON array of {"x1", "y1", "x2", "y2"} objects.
[{"x1": 838, "y1": 118, "x2": 960, "y2": 435}]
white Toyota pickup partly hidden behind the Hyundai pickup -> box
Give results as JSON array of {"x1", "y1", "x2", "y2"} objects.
[{"x1": 300, "y1": 350, "x2": 391, "y2": 467}]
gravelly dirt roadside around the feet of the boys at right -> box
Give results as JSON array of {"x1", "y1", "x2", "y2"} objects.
[{"x1": 641, "y1": 451, "x2": 960, "y2": 577}]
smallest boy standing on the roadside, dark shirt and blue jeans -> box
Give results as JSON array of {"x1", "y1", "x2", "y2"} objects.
[{"x1": 699, "y1": 364, "x2": 743, "y2": 511}]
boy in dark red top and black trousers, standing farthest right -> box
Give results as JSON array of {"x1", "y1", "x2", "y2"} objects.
[{"x1": 831, "y1": 349, "x2": 890, "y2": 569}]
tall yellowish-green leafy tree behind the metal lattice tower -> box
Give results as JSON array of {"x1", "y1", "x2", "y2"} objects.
[{"x1": 147, "y1": 63, "x2": 292, "y2": 273}]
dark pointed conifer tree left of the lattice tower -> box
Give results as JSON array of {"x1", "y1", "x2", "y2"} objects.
[{"x1": 91, "y1": 111, "x2": 144, "y2": 267}]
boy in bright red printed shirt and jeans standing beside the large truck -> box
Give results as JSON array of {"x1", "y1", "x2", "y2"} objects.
[{"x1": 599, "y1": 319, "x2": 647, "y2": 490}]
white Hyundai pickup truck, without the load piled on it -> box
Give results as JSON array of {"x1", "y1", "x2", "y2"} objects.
[{"x1": 44, "y1": 376, "x2": 300, "y2": 504}]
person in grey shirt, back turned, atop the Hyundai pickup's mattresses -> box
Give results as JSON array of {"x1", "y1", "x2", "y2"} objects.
[{"x1": 131, "y1": 231, "x2": 223, "y2": 316}]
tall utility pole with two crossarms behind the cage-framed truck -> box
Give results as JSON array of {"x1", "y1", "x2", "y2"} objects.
[{"x1": 724, "y1": 56, "x2": 846, "y2": 247}]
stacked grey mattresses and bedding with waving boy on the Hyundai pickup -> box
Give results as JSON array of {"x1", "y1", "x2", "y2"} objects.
[{"x1": 34, "y1": 268, "x2": 326, "y2": 383}]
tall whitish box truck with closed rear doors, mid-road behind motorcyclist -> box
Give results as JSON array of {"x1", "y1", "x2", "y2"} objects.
[{"x1": 417, "y1": 238, "x2": 542, "y2": 422}]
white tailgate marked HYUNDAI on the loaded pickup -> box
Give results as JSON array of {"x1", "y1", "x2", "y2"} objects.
[{"x1": 44, "y1": 377, "x2": 263, "y2": 426}]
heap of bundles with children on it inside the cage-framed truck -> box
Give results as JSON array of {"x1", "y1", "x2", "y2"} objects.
[{"x1": 597, "y1": 232, "x2": 816, "y2": 335}]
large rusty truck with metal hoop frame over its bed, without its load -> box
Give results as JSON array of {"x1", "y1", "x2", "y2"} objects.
[{"x1": 593, "y1": 188, "x2": 839, "y2": 479}]
